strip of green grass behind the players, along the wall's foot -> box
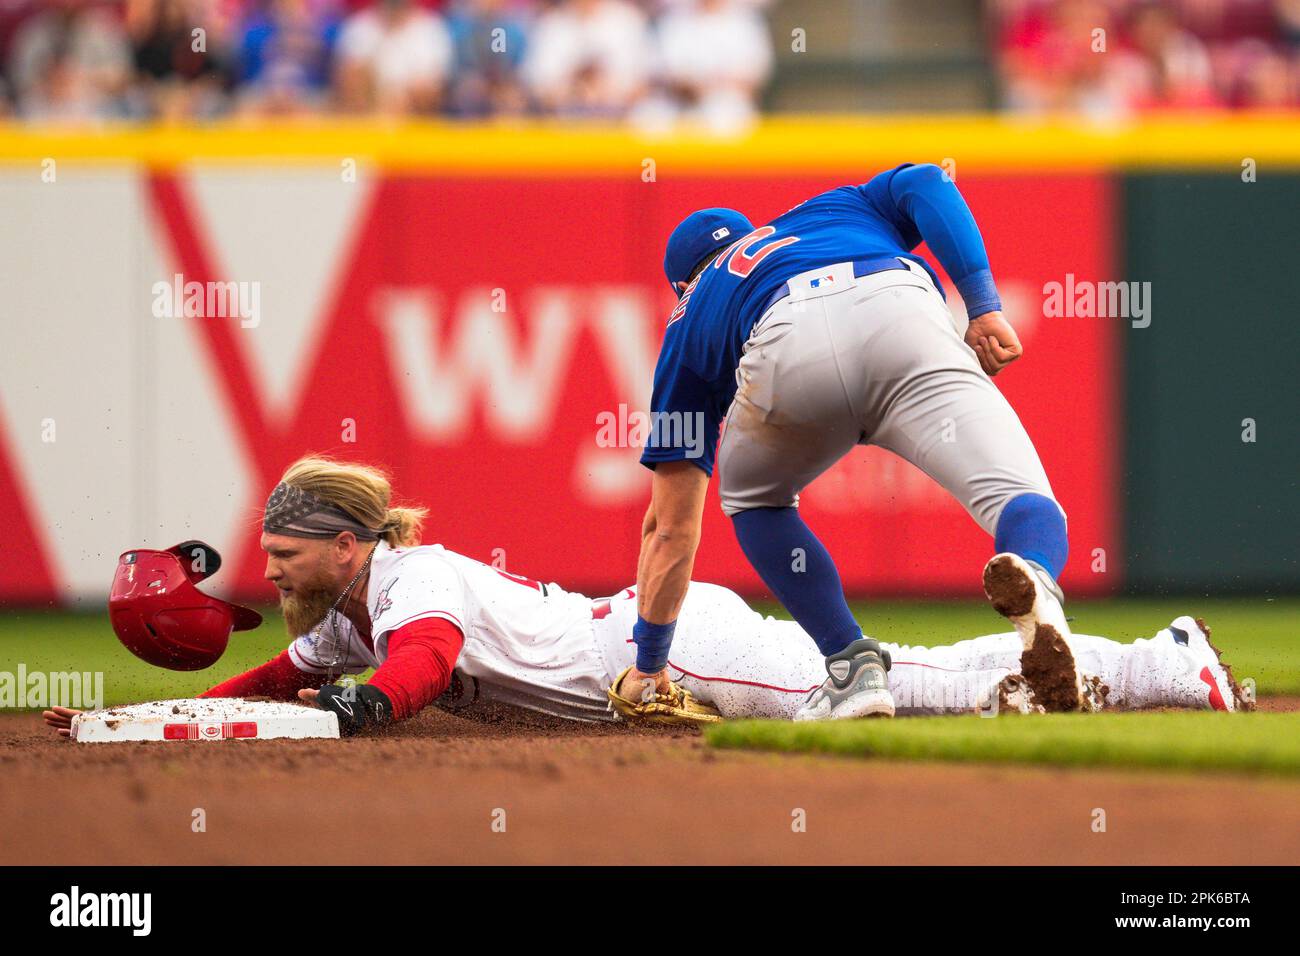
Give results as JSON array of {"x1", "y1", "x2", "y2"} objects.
[{"x1": 0, "y1": 597, "x2": 1300, "y2": 707}]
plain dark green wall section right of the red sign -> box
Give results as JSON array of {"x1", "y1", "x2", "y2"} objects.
[{"x1": 1119, "y1": 172, "x2": 1300, "y2": 593}]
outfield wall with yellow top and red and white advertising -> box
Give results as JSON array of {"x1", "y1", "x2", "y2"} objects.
[{"x1": 0, "y1": 115, "x2": 1300, "y2": 604}]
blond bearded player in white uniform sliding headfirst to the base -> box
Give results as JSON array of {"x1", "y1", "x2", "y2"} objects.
[{"x1": 46, "y1": 458, "x2": 1244, "y2": 735}]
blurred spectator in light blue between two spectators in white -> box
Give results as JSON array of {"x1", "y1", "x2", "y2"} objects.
[{"x1": 446, "y1": 0, "x2": 528, "y2": 116}]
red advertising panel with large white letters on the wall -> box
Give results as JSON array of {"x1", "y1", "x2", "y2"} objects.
[{"x1": 0, "y1": 170, "x2": 1122, "y2": 600}]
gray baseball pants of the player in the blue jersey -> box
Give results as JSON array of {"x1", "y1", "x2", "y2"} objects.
[{"x1": 718, "y1": 259, "x2": 1056, "y2": 535}]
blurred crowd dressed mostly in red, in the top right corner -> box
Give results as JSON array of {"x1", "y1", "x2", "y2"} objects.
[{"x1": 992, "y1": 0, "x2": 1300, "y2": 118}]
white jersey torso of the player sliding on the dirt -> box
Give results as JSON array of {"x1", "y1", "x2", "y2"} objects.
[{"x1": 289, "y1": 541, "x2": 612, "y2": 719}]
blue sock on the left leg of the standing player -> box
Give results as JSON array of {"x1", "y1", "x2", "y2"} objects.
[{"x1": 732, "y1": 507, "x2": 862, "y2": 657}]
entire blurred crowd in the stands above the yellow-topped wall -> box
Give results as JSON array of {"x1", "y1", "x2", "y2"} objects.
[{"x1": 0, "y1": 0, "x2": 1300, "y2": 129}]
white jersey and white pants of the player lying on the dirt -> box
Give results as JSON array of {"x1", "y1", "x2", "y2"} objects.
[{"x1": 289, "y1": 542, "x2": 1208, "y2": 721}]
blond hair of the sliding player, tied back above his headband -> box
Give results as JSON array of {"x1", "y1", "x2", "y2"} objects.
[{"x1": 280, "y1": 455, "x2": 429, "y2": 548}]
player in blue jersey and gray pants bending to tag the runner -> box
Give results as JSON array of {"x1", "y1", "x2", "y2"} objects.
[{"x1": 610, "y1": 163, "x2": 1096, "y2": 719}]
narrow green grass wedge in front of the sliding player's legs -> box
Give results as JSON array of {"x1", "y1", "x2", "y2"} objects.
[{"x1": 707, "y1": 711, "x2": 1300, "y2": 775}]
